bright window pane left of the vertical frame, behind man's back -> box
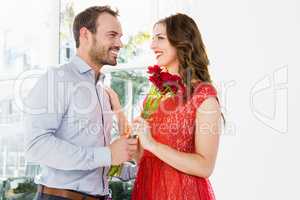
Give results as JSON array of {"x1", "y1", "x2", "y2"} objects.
[{"x1": 0, "y1": 0, "x2": 59, "y2": 200}]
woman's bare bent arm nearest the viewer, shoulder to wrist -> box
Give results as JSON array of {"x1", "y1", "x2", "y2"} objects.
[{"x1": 140, "y1": 98, "x2": 221, "y2": 178}]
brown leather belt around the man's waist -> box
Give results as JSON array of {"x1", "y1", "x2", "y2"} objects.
[{"x1": 38, "y1": 185, "x2": 107, "y2": 200}]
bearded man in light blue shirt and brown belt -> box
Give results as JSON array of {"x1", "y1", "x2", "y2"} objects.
[{"x1": 25, "y1": 6, "x2": 137, "y2": 200}]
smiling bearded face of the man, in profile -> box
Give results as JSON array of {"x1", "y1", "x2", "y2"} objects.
[{"x1": 89, "y1": 13, "x2": 123, "y2": 65}]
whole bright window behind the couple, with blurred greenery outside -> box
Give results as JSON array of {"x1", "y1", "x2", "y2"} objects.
[{"x1": 0, "y1": 0, "x2": 195, "y2": 200}]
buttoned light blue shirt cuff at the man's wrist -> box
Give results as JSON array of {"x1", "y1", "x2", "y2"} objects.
[{"x1": 94, "y1": 147, "x2": 111, "y2": 167}]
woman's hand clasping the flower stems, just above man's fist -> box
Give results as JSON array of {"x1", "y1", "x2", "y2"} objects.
[{"x1": 133, "y1": 117, "x2": 156, "y2": 152}]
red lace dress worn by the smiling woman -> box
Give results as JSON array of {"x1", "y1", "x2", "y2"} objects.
[{"x1": 132, "y1": 84, "x2": 217, "y2": 200}]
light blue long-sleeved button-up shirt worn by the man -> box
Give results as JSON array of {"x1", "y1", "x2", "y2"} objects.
[{"x1": 24, "y1": 56, "x2": 136, "y2": 195}]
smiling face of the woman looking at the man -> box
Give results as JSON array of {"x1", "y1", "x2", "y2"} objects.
[{"x1": 151, "y1": 24, "x2": 179, "y2": 68}]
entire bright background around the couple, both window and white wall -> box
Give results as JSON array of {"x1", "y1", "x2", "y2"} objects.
[{"x1": 0, "y1": 0, "x2": 300, "y2": 200}]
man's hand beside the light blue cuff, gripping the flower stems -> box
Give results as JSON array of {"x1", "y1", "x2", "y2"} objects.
[{"x1": 109, "y1": 137, "x2": 138, "y2": 165}]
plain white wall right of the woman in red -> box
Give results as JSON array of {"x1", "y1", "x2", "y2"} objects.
[{"x1": 183, "y1": 0, "x2": 300, "y2": 200}]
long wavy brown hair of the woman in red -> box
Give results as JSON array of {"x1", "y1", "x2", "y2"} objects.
[{"x1": 155, "y1": 13, "x2": 211, "y2": 95}]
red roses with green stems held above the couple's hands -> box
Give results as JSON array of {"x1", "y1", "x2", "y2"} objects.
[{"x1": 141, "y1": 65, "x2": 185, "y2": 119}]
